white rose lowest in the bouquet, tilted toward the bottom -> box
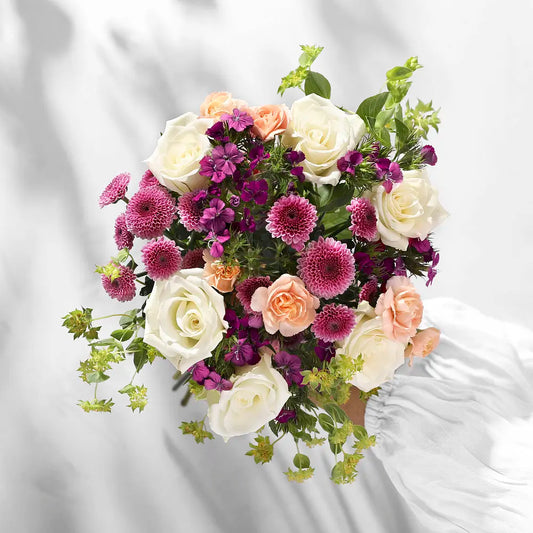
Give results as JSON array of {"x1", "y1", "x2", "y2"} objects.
[{"x1": 207, "y1": 353, "x2": 291, "y2": 440}]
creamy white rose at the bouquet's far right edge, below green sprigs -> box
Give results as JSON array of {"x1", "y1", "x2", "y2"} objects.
[{"x1": 368, "y1": 167, "x2": 448, "y2": 250}]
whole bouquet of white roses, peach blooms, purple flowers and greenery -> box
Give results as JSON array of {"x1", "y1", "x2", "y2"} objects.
[{"x1": 63, "y1": 46, "x2": 446, "y2": 483}]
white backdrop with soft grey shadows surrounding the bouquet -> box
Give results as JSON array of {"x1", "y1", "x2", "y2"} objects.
[{"x1": 0, "y1": 0, "x2": 533, "y2": 533}]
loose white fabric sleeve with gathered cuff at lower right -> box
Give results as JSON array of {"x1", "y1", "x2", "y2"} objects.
[{"x1": 366, "y1": 299, "x2": 533, "y2": 533}]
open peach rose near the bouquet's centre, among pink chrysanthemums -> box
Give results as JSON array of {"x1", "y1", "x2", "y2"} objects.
[{"x1": 250, "y1": 274, "x2": 320, "y2": 337}]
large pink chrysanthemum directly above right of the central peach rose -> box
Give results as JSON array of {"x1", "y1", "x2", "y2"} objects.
[{"x1": 298, "y1": 237, "x2": 355, "y2": 298}]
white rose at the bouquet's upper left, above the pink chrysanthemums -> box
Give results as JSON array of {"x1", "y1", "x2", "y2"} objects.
[{"x1": 146, "y1": 113, "x2": 213, "y2": 194}]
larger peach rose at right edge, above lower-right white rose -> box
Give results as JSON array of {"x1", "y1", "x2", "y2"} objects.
[{"x1": 376, "y1": 276, "x2": 424, "y2": 344}]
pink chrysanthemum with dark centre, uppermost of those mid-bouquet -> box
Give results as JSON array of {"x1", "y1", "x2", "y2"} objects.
[{"x1": 266, "y1": 194, "x2": 318, "y2": 252}]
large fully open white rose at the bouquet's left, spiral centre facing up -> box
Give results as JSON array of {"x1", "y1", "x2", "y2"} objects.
[{"x1": 144, "y1": 268, "x2": 228, "y2": 372}]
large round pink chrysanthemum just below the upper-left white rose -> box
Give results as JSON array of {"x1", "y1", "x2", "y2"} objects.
[{"x1": 126, "y1": 187, "x2": 176, "y2": 239}]
